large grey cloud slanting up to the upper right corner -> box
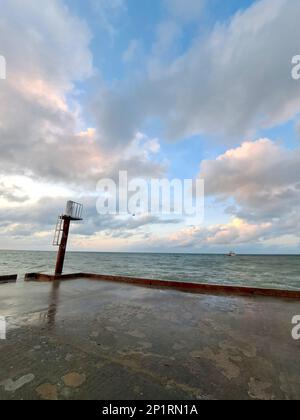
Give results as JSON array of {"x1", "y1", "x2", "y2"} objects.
[{"x1": 94, "y1": 0, "x2": 300, "y2": 147}]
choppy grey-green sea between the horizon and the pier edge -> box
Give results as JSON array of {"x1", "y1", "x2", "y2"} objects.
[{"x1": 0, "y1": 251, "x2": 300, "y2": 290}]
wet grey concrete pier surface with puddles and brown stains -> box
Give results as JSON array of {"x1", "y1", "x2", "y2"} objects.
[{"x1": 0, "y1": 279, "x2": 300, "y2": 400}]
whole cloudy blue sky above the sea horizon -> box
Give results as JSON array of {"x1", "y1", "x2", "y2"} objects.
[{"x1": 0, "y1": 0, "x2": 300, "y2": 254}]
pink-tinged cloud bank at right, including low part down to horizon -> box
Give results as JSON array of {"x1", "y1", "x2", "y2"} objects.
[{"x1": 126, "y1": 138, "x2": 300, "y2": 252}]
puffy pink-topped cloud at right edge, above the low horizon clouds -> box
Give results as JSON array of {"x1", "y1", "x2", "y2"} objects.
[{"x1": 200, "y1": 139, "x2": 300, "y2": 221}]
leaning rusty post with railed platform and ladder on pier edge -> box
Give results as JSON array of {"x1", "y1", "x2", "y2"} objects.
[{"x1": 53, "y1": 201, "x2": 83, "y2": 276}]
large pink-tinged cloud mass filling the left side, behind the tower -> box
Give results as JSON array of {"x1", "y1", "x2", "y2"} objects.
[{"x1": 0, "y1": 0, "x2": 171, "y2": 247}]
